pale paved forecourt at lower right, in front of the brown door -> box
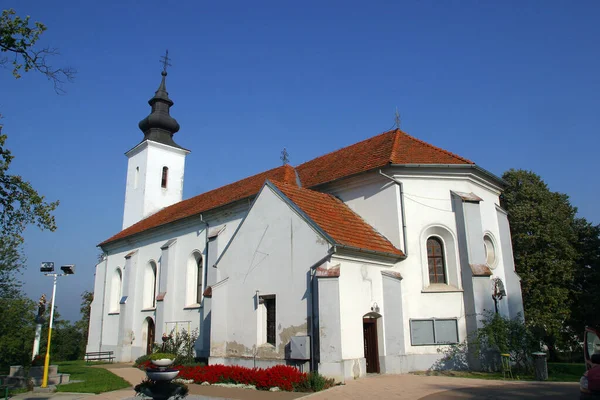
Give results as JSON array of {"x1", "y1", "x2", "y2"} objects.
[{"x1": 305, "y1": 375, "x2": 579, "y2": 400}]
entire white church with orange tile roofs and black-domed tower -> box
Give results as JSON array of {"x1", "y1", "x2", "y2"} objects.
[{"x1": 87, "y1": 71, "x2": 523, "y2": 381}]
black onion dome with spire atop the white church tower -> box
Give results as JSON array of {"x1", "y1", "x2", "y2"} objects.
[{"x1": 138, "y1": 71, "x2": 181, "y2": 147}]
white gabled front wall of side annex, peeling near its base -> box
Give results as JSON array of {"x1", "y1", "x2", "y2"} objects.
[{"x1": 210, "y1": 187, "x2": 329, "y2": 366}]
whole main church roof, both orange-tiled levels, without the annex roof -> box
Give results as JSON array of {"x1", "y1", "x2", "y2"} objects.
[{"x1": 100, "y1": 129, "x2": 473, "y2": 245}]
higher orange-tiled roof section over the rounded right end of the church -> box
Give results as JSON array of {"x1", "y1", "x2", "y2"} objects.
[{"x1": 296, "y1": 129, "x2": 474, "y2": 187}]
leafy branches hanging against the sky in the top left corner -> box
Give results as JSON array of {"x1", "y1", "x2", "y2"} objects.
[{"x1": 0, "y1": 9, "x2": 76, "y2": 93}]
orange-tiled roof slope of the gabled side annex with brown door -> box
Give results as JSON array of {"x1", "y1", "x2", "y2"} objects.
[{"x1": 271, "y1": 181, "x2": 404, "y2": 257}]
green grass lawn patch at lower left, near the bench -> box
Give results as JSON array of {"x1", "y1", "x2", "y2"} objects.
[{"x1": 56, "y1": 360, "x2": 131, "y2": 394}]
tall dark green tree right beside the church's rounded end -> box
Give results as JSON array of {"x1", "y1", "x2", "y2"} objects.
[{"x1": 502, "y1": 169, "x2": 577, "y2": 357}]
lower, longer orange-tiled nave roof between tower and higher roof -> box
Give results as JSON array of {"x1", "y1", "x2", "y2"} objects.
[{"x1": 100, "y1": 165, "x2": 296, "y2": 245}]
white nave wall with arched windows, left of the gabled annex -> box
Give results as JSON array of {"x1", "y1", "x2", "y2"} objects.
[{"x1": 95, "y1": 202, "x2": 248, "y2": 361}]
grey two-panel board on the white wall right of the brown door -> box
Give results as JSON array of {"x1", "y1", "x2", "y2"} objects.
[{"x1": 410, "y1": 318, "x2": 458, "y2": 346}]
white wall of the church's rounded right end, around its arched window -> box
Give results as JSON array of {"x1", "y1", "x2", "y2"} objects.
[{"x1": 325, "y1": 168, "x2": 505, "y2": 370}]
